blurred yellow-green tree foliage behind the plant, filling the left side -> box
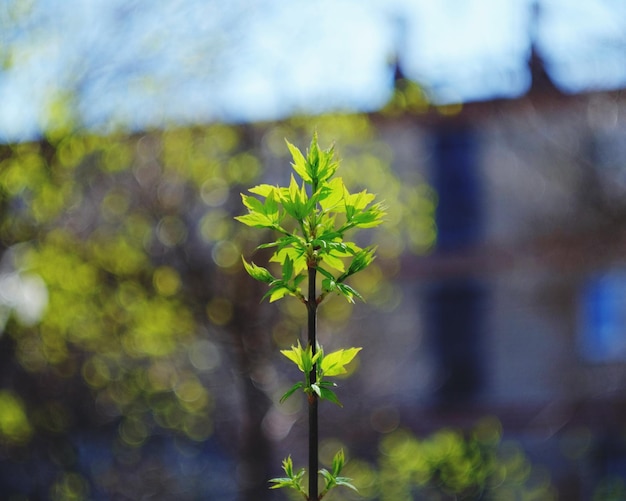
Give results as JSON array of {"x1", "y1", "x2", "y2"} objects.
[{"x1": 0, "y1": 115, "x2": 435, "y2": 468}]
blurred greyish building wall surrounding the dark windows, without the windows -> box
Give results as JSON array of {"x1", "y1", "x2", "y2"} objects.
[{"x1": 368, "y1": 89, "x2": 626, "y2": 406}]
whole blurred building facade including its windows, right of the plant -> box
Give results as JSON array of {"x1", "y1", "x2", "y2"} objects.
[{"x1": 364, "y1": 58, "x2": 626, "y2": 499}]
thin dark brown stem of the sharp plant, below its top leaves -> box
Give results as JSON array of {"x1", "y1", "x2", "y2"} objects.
[{"x1": 307, "y1": 266, "x2": 319, "y2": 501}]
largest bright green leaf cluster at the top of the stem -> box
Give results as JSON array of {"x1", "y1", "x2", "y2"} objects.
[{"x1": 235, "y1": 134, "x2": 385, "y2": 303}]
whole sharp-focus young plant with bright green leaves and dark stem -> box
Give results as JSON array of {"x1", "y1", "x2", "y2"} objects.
[{"x1": 235, "y1": 134, "x2": 384, "y2": 501}]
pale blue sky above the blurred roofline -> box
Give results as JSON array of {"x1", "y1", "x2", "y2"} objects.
[{"x1": 0, "y1": 0, "x2": 626, "y2": 140}]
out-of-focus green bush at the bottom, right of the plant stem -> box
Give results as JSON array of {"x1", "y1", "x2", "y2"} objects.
[{"x1": 316, "y1": 417, "x2": 558, "y2": 501}]
